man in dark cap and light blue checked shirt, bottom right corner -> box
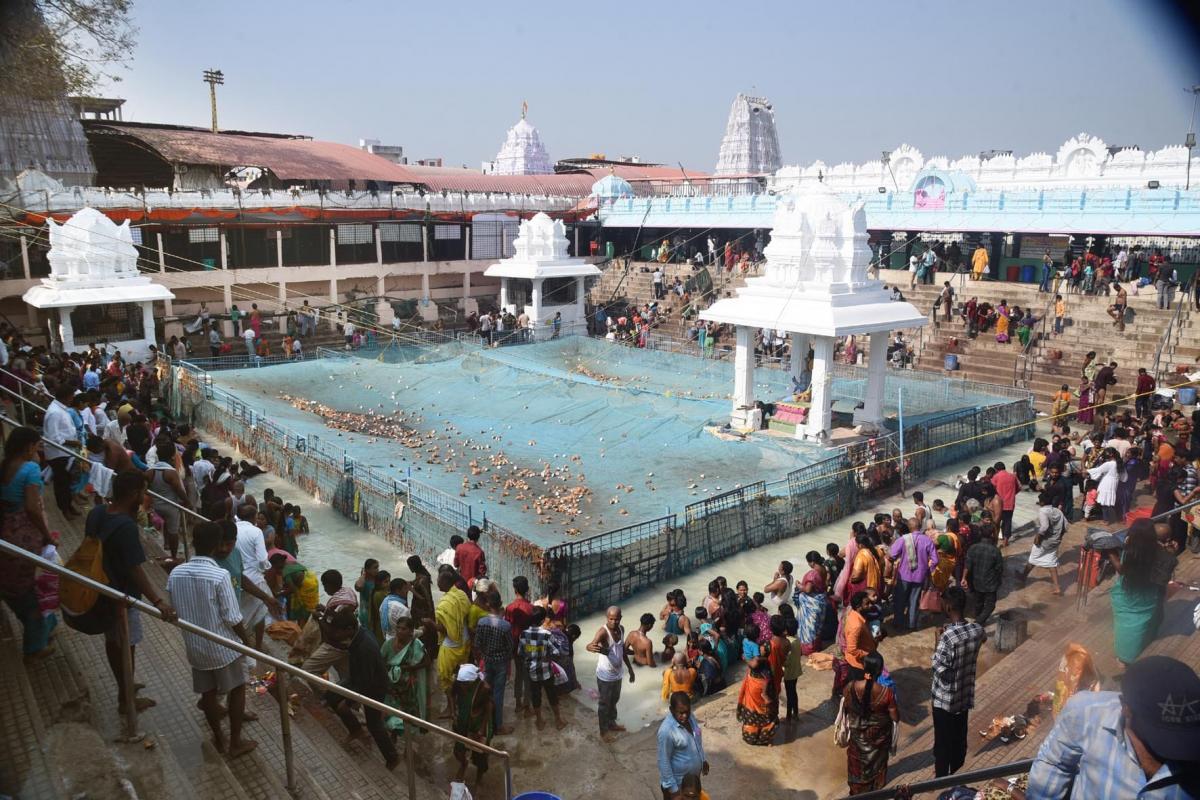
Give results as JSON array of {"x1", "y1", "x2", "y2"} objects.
[{"x1": 1025, "y1": 656, "x2": 1200, "y2": 800}]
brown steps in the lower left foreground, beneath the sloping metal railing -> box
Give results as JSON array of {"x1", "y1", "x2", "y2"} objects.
[{"x1": 0, "y1": 507, "x2": 448, "y2": 800}]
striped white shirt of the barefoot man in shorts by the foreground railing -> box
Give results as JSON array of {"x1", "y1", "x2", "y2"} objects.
[{"x1": 167, "y1": 555, "x2": 241, "y2": 669}]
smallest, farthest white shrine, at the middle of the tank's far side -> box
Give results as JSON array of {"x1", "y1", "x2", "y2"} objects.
[{"x1": 484, "y1": 212, "x2": 600, "y2": 338}]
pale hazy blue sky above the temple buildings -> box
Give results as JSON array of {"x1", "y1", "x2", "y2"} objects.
[{"x1": 108, "y1": 0, "x2": 1200, "y2": 170}]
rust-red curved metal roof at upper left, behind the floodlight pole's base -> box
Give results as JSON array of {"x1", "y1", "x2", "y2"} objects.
[{"x1": 84, "y1": 120, "x2": 420, "y2": 184}]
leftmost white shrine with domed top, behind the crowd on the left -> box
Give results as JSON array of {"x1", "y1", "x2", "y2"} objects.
[{"x1": 24, "y1": 207, "x2": 175, "y2": 361}]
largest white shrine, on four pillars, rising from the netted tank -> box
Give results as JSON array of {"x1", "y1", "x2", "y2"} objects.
[{"x1": 700, "y1": 184, "x2": 928, "y2": 441}]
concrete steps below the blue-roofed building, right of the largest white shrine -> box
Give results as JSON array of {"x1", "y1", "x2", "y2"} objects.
[{"x1": 902, "y1": 272, "x2": 1200, "y2": 411}]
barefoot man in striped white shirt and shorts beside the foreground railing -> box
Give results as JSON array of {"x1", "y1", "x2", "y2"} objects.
[{"x1": 167, "y1": 522, "x2": 257, "y2": 758}]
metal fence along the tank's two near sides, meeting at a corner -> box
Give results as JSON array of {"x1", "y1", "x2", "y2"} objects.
[{"x1": 163, "y1": 339, "x2": 1034, "y2": 613}]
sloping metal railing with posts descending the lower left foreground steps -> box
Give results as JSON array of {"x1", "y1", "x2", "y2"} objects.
[{"x1": 0, "y1": 540, "x2": 512, "y2": 800}]
